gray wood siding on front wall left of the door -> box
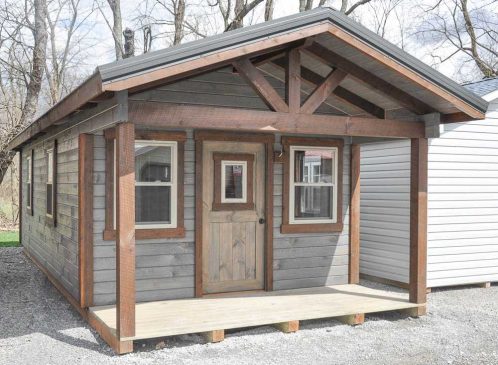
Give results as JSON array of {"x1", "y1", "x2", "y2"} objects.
[{"x1": 94, "y1": 132, "x2": 195, "y2": 305}]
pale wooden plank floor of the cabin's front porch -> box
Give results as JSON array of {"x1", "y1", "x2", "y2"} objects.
[{"x1": 90, "y1": 284, "x2": 419, "y2": 341}]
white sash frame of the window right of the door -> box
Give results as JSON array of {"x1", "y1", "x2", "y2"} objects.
[{"x1": 289, "y1": 146, "x2": 339, "y2": 224}]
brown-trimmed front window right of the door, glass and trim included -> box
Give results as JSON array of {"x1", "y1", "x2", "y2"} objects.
[{"x1": 282, "y1": 137, "x2": 343, "y2": 233}]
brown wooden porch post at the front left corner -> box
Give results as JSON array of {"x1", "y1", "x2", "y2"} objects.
[{"x1": 116, "y1": 122, "x2": 135, "y2": 339}]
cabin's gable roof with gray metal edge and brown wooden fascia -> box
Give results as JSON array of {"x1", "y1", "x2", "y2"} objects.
[{"x1": 9, "y1": 7, "x2": 487, "y2": 149}]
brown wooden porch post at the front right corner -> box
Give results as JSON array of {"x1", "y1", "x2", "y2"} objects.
[{"x1": 410, "y1": 138, "x2": 428, "y2": 304}]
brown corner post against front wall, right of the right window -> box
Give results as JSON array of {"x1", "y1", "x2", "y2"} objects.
[{"x1": 349, "y1": 144, "x2": 361, "y2": 284}]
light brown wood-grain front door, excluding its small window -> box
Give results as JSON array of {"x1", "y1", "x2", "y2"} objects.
[{"x1": 203, "y1": 141, "x2": 265, "y2": 294}]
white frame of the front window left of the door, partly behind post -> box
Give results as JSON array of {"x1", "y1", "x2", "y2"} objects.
[{"x1": 113, "y1": 139, "x2": 178, "y2": 230}]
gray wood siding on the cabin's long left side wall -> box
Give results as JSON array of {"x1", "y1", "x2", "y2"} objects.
[{"x1": 22, "y1": 105, "x2": 119, "y2": 298}]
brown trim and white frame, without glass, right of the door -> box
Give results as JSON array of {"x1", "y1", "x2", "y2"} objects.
[{"x1": 280, "y1": 137, "x2": 344, "y2": 234}]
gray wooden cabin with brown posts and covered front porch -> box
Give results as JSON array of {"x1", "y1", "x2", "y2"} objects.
[{"x1": 9, "y1": 8, "x2": 487, "y2": 354}]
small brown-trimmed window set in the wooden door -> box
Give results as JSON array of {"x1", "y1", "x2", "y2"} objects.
[{"x1": 212, "y1": 152, "x2": 254, "y2": 211}]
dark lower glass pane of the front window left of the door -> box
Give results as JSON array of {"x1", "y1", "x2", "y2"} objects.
[{"x1": 135, "y1": 186, "x2": 171, "y2": 225}]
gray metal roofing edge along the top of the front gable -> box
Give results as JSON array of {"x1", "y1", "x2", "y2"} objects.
[{"x1": 98, "y1": 7, "x2": 487, "y2": 112}]
